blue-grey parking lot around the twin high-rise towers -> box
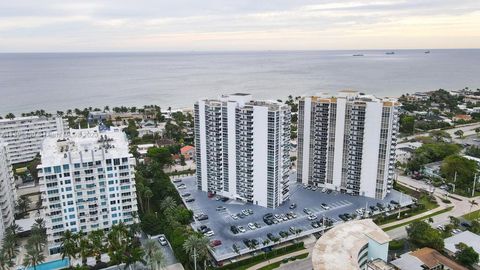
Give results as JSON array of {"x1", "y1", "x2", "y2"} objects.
[{"x1": 175, "y1": 177, "x2": 413, "y2": 261}]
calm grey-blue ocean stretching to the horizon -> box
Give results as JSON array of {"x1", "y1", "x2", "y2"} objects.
[{"x1": 0, "y1": 49, "x2": 480, "y2": 115}]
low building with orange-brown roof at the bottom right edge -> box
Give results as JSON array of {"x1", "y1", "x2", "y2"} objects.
[{"x1": 390, "y1": 247, "x2": 468, "y2": 270}]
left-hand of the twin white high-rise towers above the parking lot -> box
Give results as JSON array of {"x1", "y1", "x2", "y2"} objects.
[{"x1": 195, "y1": 93, "x2": 291, "y2": 208}]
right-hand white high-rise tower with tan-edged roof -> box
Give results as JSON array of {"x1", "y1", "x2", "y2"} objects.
[{"x1": 297, "y1": 91, "x2": 399, "y2": 199}]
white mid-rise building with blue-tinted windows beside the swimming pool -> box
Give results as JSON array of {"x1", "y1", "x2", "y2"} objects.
[{"x1": 38, "y1": 128, "x2": 137, "y2": 254}]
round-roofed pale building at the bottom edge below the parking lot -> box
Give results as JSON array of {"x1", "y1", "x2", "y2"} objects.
[{"x1": 312, "y1": 219, "x2": 391, "y2": 270}]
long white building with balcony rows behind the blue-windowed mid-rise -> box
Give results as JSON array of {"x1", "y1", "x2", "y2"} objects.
[{"x1": 0, "y1": 116, "x2": 68, "y2": 164}]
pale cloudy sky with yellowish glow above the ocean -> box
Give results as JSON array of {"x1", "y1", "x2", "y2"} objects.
[{"x1": 0, "y1": 0, "x2": 480, "y2": 52}]
